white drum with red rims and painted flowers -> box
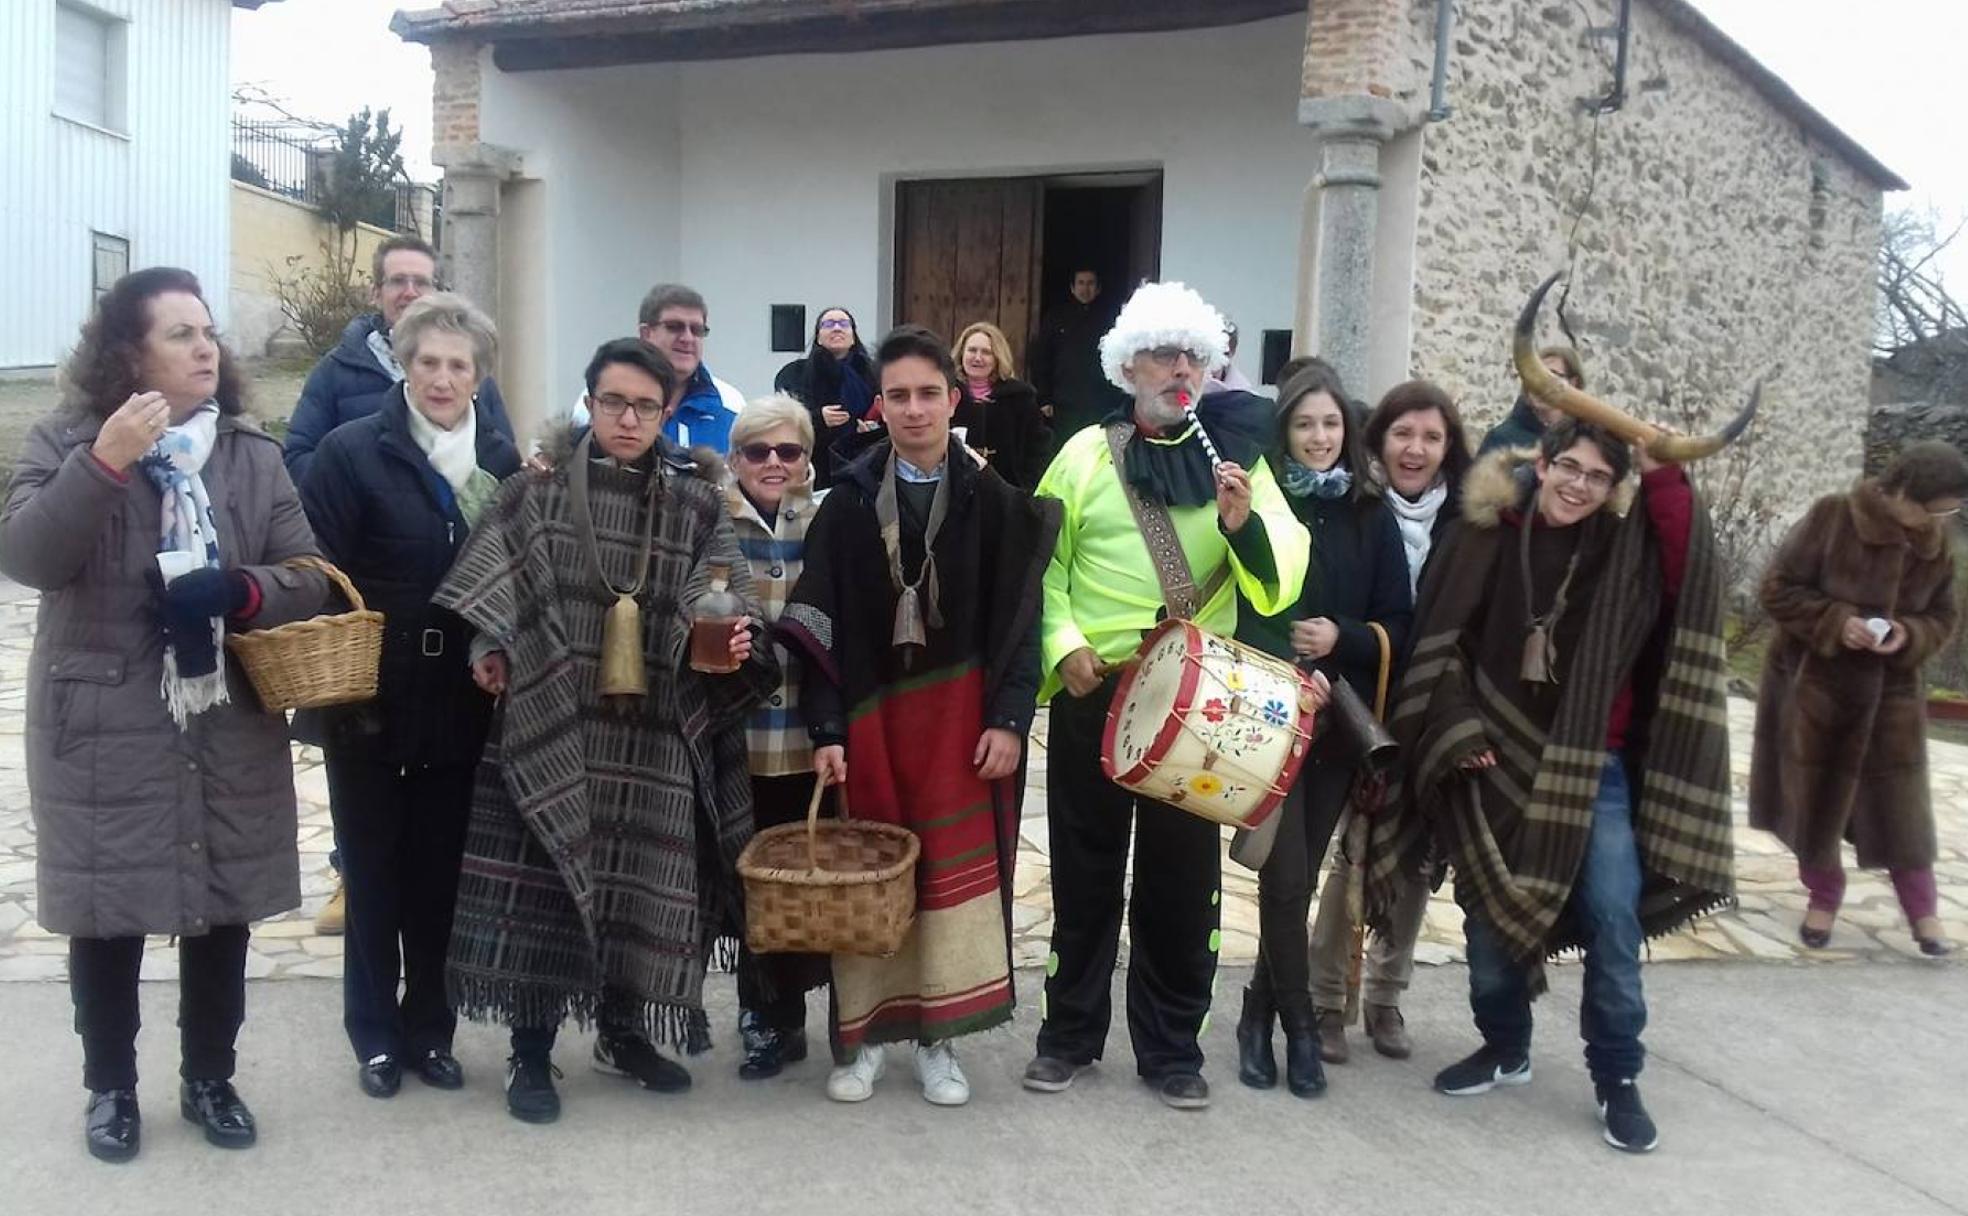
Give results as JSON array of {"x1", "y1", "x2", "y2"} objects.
[{"x1": 1100, "y1": 620, "x2": 1313, "y2": 828}]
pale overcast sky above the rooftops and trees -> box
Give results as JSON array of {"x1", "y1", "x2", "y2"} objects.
[{"x1": 232, "y1": 0, "x2": 1968, "y2": 295}]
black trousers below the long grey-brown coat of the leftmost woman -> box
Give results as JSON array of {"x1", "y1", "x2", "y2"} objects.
[{"x1": 69, "y1": 925, "x2": 246, "y2": 1090}]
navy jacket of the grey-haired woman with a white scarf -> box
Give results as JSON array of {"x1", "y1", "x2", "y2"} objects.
[{"x1": 295, "y1": 386, "x2": 520, "y2": 765}]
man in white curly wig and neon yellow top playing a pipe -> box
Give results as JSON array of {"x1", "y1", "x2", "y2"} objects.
[{"x1": 1025, "y1": 283, "x2": 1311, "y2": 1110}]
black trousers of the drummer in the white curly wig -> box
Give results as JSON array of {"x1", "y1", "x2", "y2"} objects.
[{"x1": 1039, "y1": 679, "x2": 1222, "y2": 1078}]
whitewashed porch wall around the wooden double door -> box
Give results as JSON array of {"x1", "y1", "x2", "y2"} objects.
[{"x1": 480, "y1": 16, "x2": 1313, "y2": 411}]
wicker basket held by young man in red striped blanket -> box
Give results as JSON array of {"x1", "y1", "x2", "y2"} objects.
[{"x1": 738, "y1": 779, "x2": 923, "y2": 958}]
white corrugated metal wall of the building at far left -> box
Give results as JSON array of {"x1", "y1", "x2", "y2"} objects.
[{"x1": 0, "y1": 0, "x2": 232, "y2": 368}]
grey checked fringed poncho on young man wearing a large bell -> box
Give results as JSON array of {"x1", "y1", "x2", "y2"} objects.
[{"x1": 435, "y1": 432, "x2": 777, "y2": 1049}]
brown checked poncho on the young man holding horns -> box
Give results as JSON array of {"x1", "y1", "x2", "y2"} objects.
[{"x1": 1366, "y1": 453, "x2": 1734, "y2": 992}]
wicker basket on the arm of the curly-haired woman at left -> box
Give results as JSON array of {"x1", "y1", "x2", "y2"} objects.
[{"x1": 226, "y1": 557, "x2": 382, "y2": 714}]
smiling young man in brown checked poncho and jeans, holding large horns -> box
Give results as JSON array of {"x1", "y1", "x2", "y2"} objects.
[{"x1": 1368, "y1": 417, "x2": 1730, "y2": 1153}]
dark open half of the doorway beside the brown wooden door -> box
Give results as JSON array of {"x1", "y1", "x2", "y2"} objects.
[{"x1": 1039, "y1": 173, "x2": 1161, "y2": 313}]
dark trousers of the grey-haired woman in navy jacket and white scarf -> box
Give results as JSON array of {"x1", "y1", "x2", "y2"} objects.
[{"x1": 327, "y1": 746, "x2": 472, "y2": 1061}]
